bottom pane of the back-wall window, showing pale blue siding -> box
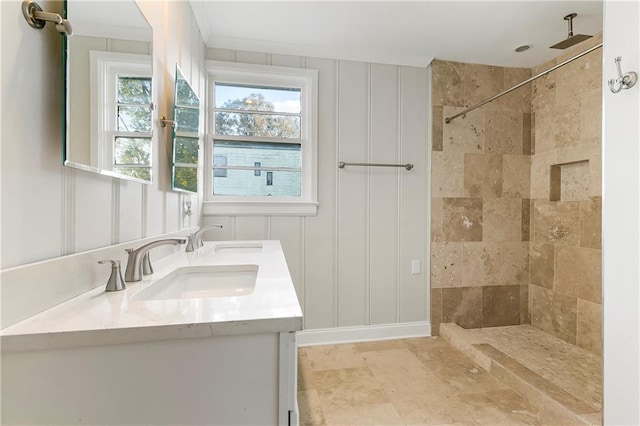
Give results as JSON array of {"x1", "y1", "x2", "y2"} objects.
[{"x1": 213, "y1": 169, "x2": 301, "y2": 197}]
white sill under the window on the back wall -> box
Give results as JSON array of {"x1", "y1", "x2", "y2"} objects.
[{"x1": 202, "y1": 201, "x2": 318, "y2": 216}]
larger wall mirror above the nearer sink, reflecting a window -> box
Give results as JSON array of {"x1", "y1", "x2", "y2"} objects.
[{"x1": 64, "y1": 0, "x2": 154, "y2": 183}]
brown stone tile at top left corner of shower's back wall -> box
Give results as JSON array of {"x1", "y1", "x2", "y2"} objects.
[{"x1": 432, "y1": 60, "x2": 465, "y2": 107}]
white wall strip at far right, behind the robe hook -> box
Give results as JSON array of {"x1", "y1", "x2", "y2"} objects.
[{"x1": 602, "y1": 0, "x2": 640, "y2": 425}]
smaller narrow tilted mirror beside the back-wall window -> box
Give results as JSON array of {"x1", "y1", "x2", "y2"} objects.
[{"x1": 171, "y1": 65, "x2": 200, "y2": 193}]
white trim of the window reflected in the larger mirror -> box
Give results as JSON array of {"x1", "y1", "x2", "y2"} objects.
[{"x1": 89, "y1": 50, "x2": 155, "y2": 183}]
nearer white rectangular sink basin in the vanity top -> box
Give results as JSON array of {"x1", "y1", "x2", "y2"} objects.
[{"x1": 133, "y1": 265, "x2": 258, "y2": 300}]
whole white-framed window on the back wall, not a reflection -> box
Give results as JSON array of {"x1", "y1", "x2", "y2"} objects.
[{"x1": 204, "y1": 61, "x2": 317, "y2": 215}]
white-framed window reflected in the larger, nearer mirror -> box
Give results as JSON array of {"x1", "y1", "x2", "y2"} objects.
[{"x1": 90, "y1": 51, "x2": 153, "y2": 181}]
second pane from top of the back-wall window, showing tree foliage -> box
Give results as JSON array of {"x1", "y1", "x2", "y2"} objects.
[{"x1": 216, "y1": 112, "x2": 300, "y2": 139}]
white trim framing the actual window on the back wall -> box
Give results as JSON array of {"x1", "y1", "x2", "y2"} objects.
[{"x1": 203, "y1": 60, "x2": 318, "y2": 216}]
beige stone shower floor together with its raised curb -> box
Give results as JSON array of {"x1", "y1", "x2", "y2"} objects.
[{"x1": 440, "y1": 324, "x2": 602, "y2": 425}]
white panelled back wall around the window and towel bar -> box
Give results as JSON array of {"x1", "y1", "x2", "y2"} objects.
[{"x1": 204, "y1": 49, "x2": 430, "y2": 333}]
